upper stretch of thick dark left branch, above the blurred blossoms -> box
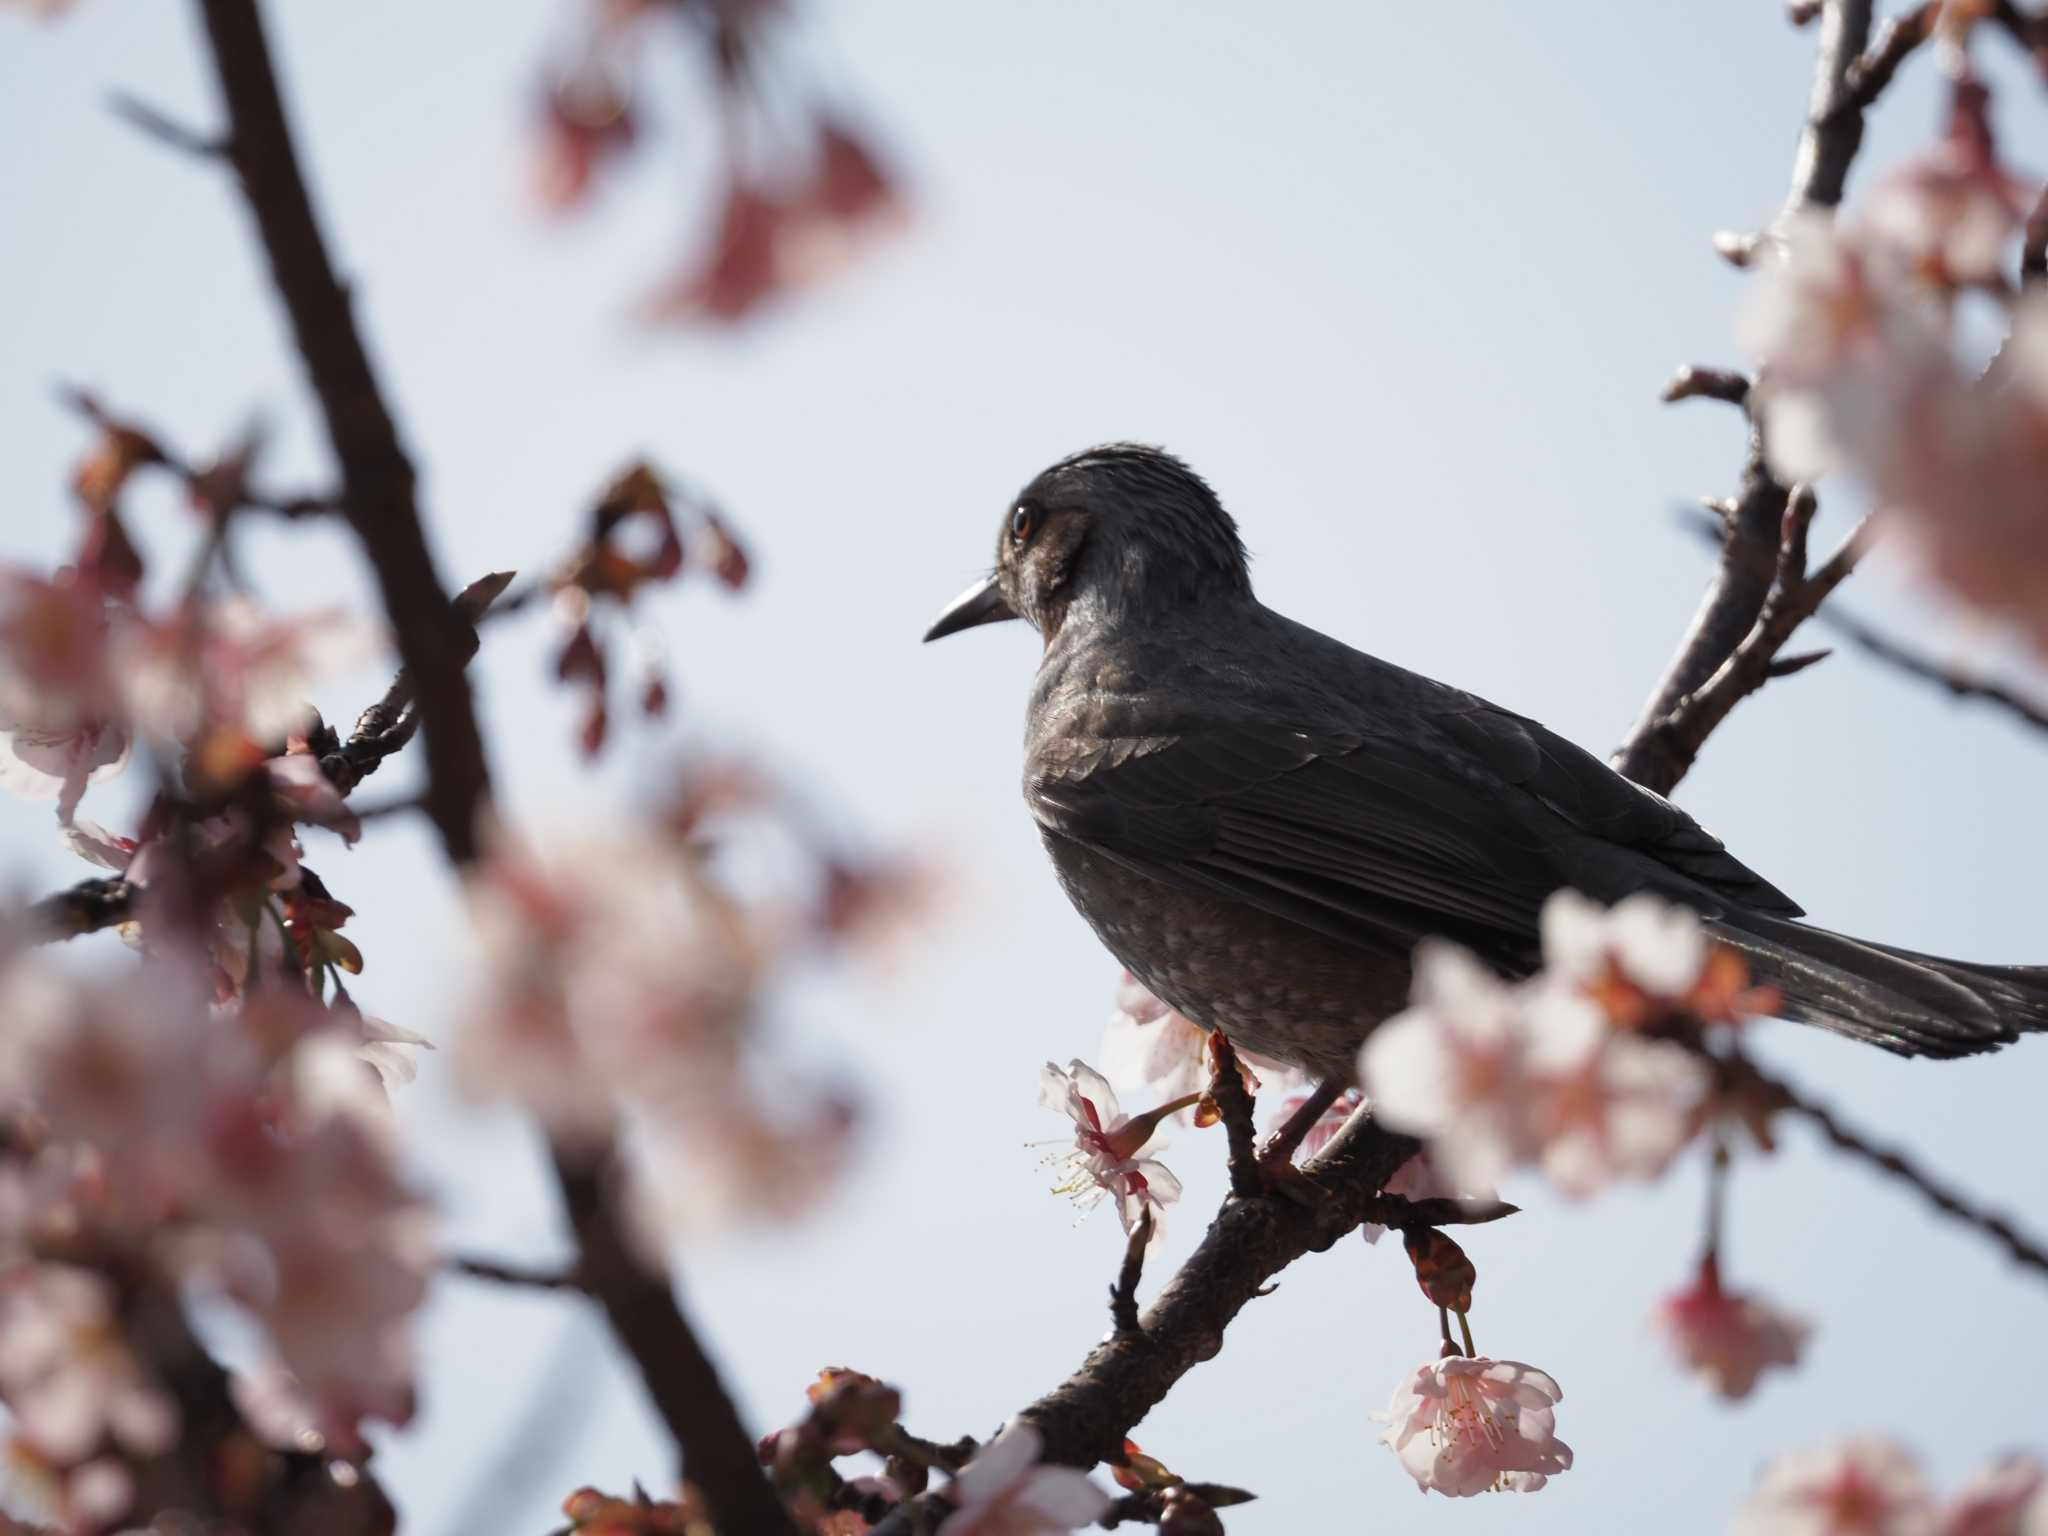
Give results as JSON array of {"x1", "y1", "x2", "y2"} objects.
[{"x1": 201, "y1": 0, "x2": 489, "y2": 864}]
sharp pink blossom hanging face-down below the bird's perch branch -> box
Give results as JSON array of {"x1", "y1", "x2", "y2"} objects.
[{"x1": 1376, "y1": 1356, "x2": 1571, "y2": 1499}]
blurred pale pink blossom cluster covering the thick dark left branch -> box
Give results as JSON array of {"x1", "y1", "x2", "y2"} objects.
[{"x1": 457, "y1": 764, "x2": 913, "y2": 1237}]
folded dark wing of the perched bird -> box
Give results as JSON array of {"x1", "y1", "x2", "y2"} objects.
[{"x1": 1028, "y1": 700, "x2": 1796, "y2": 963}]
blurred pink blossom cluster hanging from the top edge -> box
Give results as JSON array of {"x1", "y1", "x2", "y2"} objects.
[{"x1": 539, "y1": 0, "x2": 903, "y2": 324}]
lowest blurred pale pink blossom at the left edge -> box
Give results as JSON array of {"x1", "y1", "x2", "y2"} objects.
[{"x1": 0, "y1": 1264, "x2": 178, "y2": 1466}]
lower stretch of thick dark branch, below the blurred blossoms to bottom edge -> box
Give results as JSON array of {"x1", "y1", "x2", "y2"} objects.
[{"x1": 553, "y1": 1143, "x2": 797, "y2": 1536}]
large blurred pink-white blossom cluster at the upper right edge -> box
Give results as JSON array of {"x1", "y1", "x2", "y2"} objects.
[{"x1": 1743, "y1": 57, "x2": 2048, "y2": 647}]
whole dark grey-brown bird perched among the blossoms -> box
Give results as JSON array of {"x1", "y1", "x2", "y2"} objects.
[{"x1": 926, "y1": 444, "x2": 2048, "y2": 1083}]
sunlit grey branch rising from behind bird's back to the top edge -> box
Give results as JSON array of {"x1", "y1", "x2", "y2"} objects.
[{"x1": 1610, "y1": 0, "x2": 1872, "y2": 795}]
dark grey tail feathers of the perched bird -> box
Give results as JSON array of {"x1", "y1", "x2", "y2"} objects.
[{"x1": 1710, "y1": 911, "x2": 2048, "y2": 1057}]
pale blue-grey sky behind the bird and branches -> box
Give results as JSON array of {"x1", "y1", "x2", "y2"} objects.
[{"x1": 0, "y1": 0, "x2": 2048, "y2": 1536}]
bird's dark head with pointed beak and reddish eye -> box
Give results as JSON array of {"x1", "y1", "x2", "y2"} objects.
[{"x1": 924, "y1": 442, "x2": 1251, "y2": 643}]
